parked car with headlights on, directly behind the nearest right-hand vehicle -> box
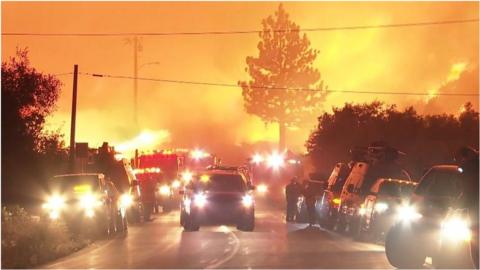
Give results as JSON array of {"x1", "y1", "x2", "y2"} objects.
[{"x1": 357, "y1": 178, "x2": 417, "y2": 240}]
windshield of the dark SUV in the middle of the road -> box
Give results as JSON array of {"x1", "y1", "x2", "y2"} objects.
[{"x1": 199, "y1": 174, "x2": 246, "y2": 192}]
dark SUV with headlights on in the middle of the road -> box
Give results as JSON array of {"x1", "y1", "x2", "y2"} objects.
[{"x1": 180, "y1": 170, "x2": 255, "y2": 231}]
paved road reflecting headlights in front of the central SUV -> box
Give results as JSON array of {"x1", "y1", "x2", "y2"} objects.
[{"x1": 42, "y1": 201, "x2": 392, "y2": 268}]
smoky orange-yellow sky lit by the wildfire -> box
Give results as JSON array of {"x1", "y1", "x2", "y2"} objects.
[{"x1": 1, "y1": 2, "x2": 479, "y2": 160}]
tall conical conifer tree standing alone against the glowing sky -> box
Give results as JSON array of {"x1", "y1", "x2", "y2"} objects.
[{"x1": 239, "y1": 4, "x2": 326, "y2": 149}]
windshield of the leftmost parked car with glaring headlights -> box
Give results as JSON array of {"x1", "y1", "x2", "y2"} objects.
[{"x1": 49, "y1": 175, "x2": 99, "y2": 193}]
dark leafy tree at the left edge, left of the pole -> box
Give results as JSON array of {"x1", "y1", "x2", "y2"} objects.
[{"x1": 2, "y1": 49, "x2": 65, "y2": 201}]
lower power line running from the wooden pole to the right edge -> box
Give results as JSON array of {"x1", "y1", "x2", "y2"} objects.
[{"x1": 79, "y1": 72, "x2": 479, "y2": 97}]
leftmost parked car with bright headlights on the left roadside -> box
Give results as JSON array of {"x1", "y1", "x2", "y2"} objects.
[{"x1": 42, "y1": 173, "x2": 127, "y2": 236}]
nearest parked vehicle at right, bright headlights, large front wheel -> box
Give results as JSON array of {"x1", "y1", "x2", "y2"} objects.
[{"x1": 385, "y1": 165, "x2": 472, "y2": 268}]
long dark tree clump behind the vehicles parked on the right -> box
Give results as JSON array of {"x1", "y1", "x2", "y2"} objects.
[{"x1": 306, "y1": 102, "x2": 479, "y2": 179}]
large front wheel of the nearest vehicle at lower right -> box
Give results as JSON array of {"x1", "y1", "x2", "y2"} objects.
[{"x1": 385, "y1": 223, "x2": 426, "y2": 269}]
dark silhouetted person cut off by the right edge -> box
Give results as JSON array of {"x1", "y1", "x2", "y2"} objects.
[{"x1": 455, "y1": 147, "x2": 479, "y2": 269}]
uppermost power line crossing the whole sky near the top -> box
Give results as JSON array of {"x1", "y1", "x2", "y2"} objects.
[{"x1": 2, "y1": 18, "x2": 479, "y2": 37}]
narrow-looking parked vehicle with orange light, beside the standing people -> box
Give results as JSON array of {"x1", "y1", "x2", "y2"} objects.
[{"x1": 317, "y1": 163, "x2": 351, "y2": 229}]
